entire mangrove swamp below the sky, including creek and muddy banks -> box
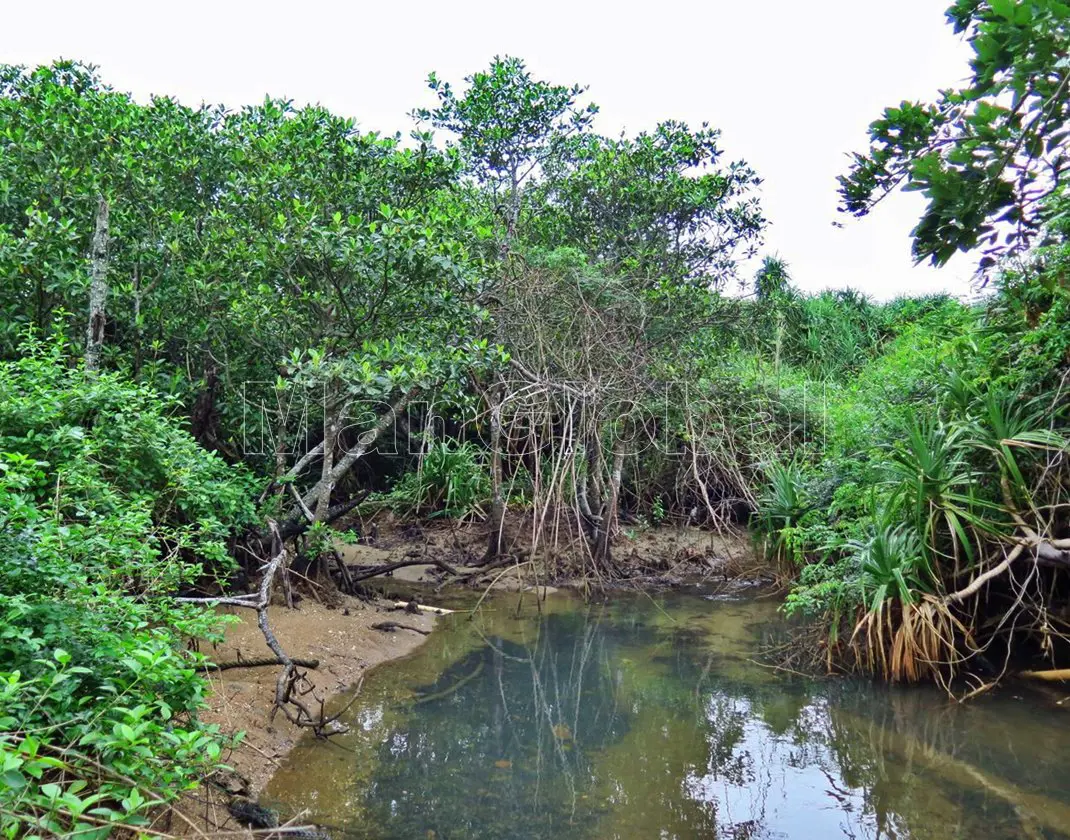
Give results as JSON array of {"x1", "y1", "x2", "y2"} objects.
[{"x1": 0, "y1": 0, "x2": 1070, "y2": 840}]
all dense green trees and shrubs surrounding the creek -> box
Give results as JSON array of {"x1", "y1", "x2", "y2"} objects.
[{"x1": 0, "y1": 0, "x2": 1070, "y2": 837}]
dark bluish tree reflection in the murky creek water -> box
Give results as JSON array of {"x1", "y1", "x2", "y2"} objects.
[{"x1": 365, "y1": 614, "x2": 629, "y2": 838}]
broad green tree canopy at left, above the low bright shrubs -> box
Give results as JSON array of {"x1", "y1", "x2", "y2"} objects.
[{"x1": 0, "y1": 63, "x2": 488, "y2": 470}]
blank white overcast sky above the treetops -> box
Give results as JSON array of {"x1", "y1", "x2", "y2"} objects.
[{"x1": 6, "y1": 0, "x2": 972, "y2": 299}]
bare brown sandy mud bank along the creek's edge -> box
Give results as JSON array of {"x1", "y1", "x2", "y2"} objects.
[{"x1": 171, "y1": 523, "x2": 753, "y2": 833}]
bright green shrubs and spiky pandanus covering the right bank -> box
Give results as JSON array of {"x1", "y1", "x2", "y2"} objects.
[{"x1": 742, "y1": 235, "x2": 1068, "y2": 679}]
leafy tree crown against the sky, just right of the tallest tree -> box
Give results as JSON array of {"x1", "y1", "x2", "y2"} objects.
[{"x1": 533, "y1": 122, "x2": 765, "y2": 289}]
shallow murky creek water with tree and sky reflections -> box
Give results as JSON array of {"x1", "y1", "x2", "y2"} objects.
[{"x1": 264, "y1": 594, "x2": 1070, "y2": 840}]
